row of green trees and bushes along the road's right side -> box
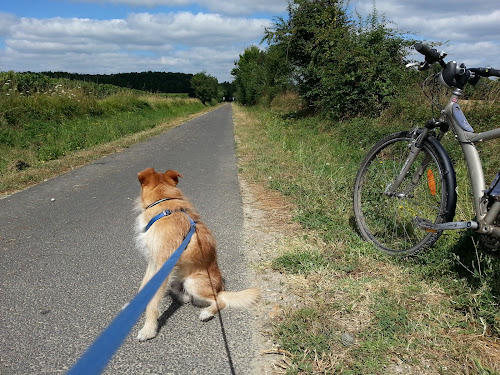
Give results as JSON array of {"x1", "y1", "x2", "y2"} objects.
[{"x1": 232, "y1": 0, "x2": 414, "y2": 119}]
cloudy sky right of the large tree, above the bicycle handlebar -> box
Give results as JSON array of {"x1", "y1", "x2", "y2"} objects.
[{"x1": 350, "y1": 0, "x2": 500, "y2": 69}]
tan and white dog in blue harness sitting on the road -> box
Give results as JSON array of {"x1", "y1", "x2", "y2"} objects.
[{"x1": 136, "y1": 168, "x2": 260, "y2": 341}]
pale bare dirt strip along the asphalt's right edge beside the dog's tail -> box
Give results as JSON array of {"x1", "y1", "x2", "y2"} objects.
[{"x1": 240, "y1": 177, "x2": 301, "y2": 375}]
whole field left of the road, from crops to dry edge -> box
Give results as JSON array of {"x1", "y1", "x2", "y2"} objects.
[{"x1": 0, "y1": 72, "x2": 208, "y2": 194}]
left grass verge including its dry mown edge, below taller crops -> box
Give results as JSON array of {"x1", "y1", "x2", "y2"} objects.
[{"x1": 0, "y1": 94, "x2": 218, "y2": 196}]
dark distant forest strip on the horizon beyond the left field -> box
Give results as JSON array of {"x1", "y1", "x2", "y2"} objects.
[{"x1": 42, "y1": 71, "x2": 194, "y2": 96}]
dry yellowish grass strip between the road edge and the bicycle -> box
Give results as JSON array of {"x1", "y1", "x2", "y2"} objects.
[{"x1": 234, "y1": 106, "x2": 500, "y2": 375}]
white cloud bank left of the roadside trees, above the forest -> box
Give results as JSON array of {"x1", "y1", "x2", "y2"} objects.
[{"x1": 0, "y1": 12, "x2": 270, "y2": 81}]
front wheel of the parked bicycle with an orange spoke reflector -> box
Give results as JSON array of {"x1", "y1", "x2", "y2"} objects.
[{"x1": 353, "y1": 132, "x2": 456, "y2": 255}]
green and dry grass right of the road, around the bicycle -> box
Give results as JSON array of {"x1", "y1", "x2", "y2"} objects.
[{"x1": 235, "y1": 93, "x2": 500, "y2": 374}]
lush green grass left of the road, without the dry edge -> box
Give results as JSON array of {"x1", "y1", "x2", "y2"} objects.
[{"x1": 0, "y1": 94, "x2": 204, "y2": 165}]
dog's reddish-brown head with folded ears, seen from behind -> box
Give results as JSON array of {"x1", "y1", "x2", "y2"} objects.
[{"x1": 137, "y1": 168, "x2": 182, "y2": 202}]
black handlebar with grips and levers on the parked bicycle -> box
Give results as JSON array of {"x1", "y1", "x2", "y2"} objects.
[{"x1": 414, "y1": 43, "x2": 500, "y2": 89}]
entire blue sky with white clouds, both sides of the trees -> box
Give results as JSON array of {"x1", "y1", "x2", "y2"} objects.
[{"x1": 0, "y1": 0, "x2": 500, "y2": 82}]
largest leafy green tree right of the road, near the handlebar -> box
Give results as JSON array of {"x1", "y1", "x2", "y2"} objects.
[{"x1": 265, "y1": 0, "x2": 411, "y2": 118}]
